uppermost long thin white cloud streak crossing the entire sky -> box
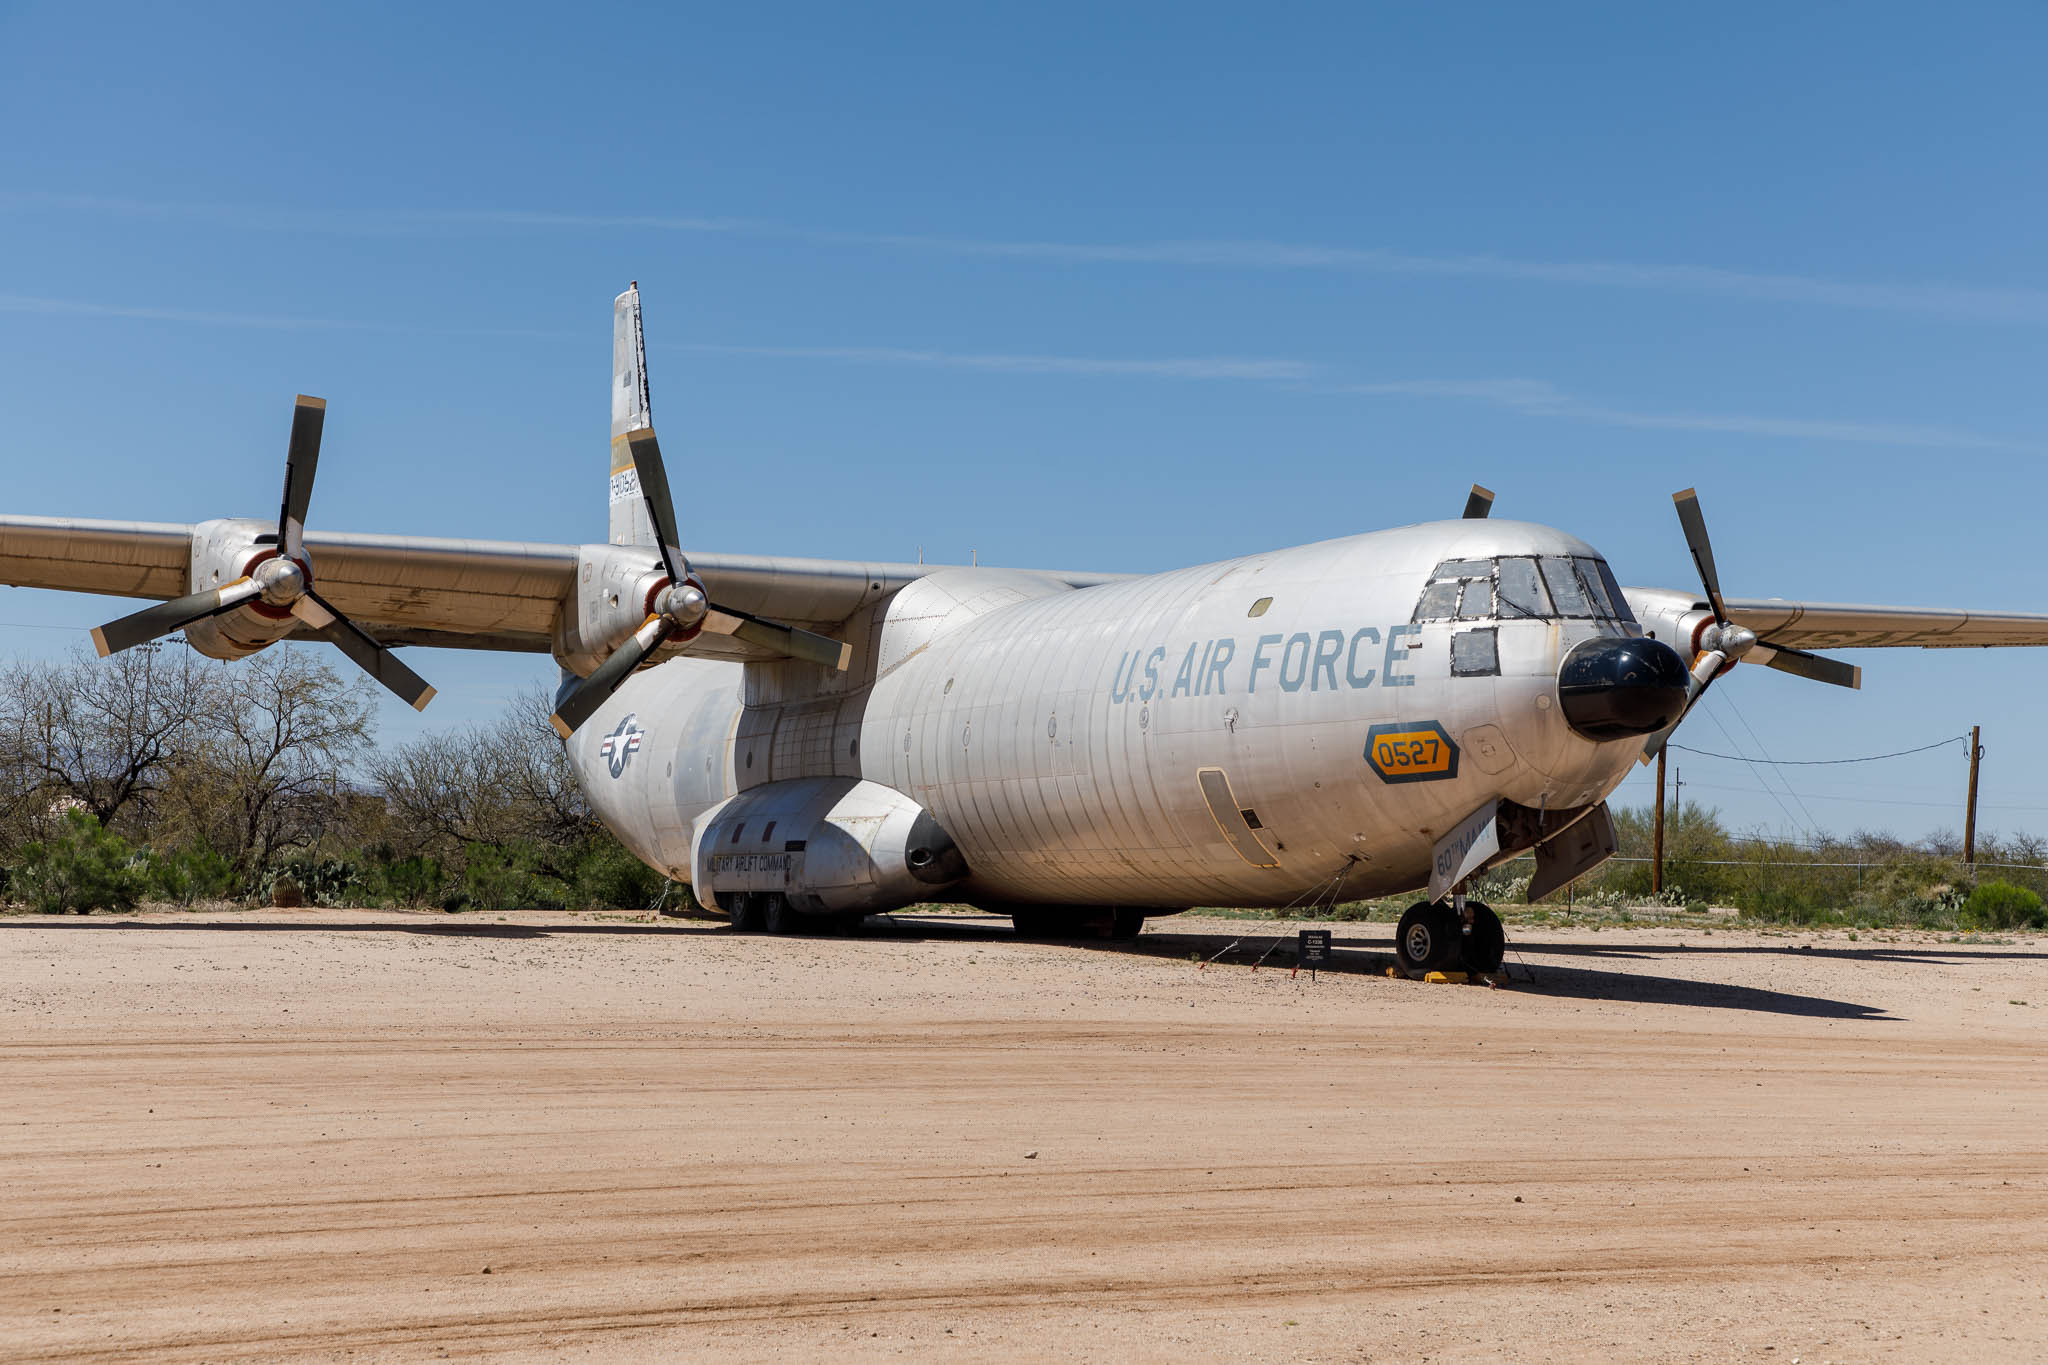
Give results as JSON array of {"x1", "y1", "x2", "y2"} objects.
[{"x1": 16, "y1": 190, "x2": 2048, "y2": 323}]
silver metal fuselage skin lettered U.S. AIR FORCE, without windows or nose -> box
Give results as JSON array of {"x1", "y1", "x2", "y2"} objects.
[{"x1": 569, "y1": 520, "x2": 1640, "y2": 909}]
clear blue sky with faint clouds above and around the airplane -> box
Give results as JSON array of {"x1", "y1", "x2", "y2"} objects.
[{"x1": 0, "y1": 4, "x2": 2048, "y2": 833}]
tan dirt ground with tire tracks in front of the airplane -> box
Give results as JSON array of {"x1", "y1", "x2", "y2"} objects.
[{"x1": 0, "y1": 911, "x2": 2048, "y2": 1365}]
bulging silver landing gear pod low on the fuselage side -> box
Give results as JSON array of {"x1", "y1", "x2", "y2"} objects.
[{"x1": 690, "y1": 778, "x2": 967, "y2": 915}]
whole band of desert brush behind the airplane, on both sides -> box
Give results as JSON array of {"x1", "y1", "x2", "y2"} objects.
[{"x1": 0, "y1": 641, "x2": 2048, "y2": 929}]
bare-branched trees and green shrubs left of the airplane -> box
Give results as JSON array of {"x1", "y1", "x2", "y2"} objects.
[{"x1": 0, "y1": 643, "x2": 682, "y2": 913}]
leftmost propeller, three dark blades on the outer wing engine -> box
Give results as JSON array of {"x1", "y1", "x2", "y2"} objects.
[{"x1": 92, "y1": 393, "x2": 434, "y2": 710}]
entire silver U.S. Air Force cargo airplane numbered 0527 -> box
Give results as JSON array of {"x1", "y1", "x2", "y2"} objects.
[{"x1": 0, "y1": 282, "x2": 2048, "y2": 974}]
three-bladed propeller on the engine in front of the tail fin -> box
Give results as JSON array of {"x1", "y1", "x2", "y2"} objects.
[{"x1": 549, "y1": 428, "x2": 854, "y2": 739}]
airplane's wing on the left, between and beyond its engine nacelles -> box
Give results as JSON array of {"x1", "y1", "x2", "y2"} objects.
[{"x1": 0, "y1": 516, "x2": 1120, "y2": 659}]
